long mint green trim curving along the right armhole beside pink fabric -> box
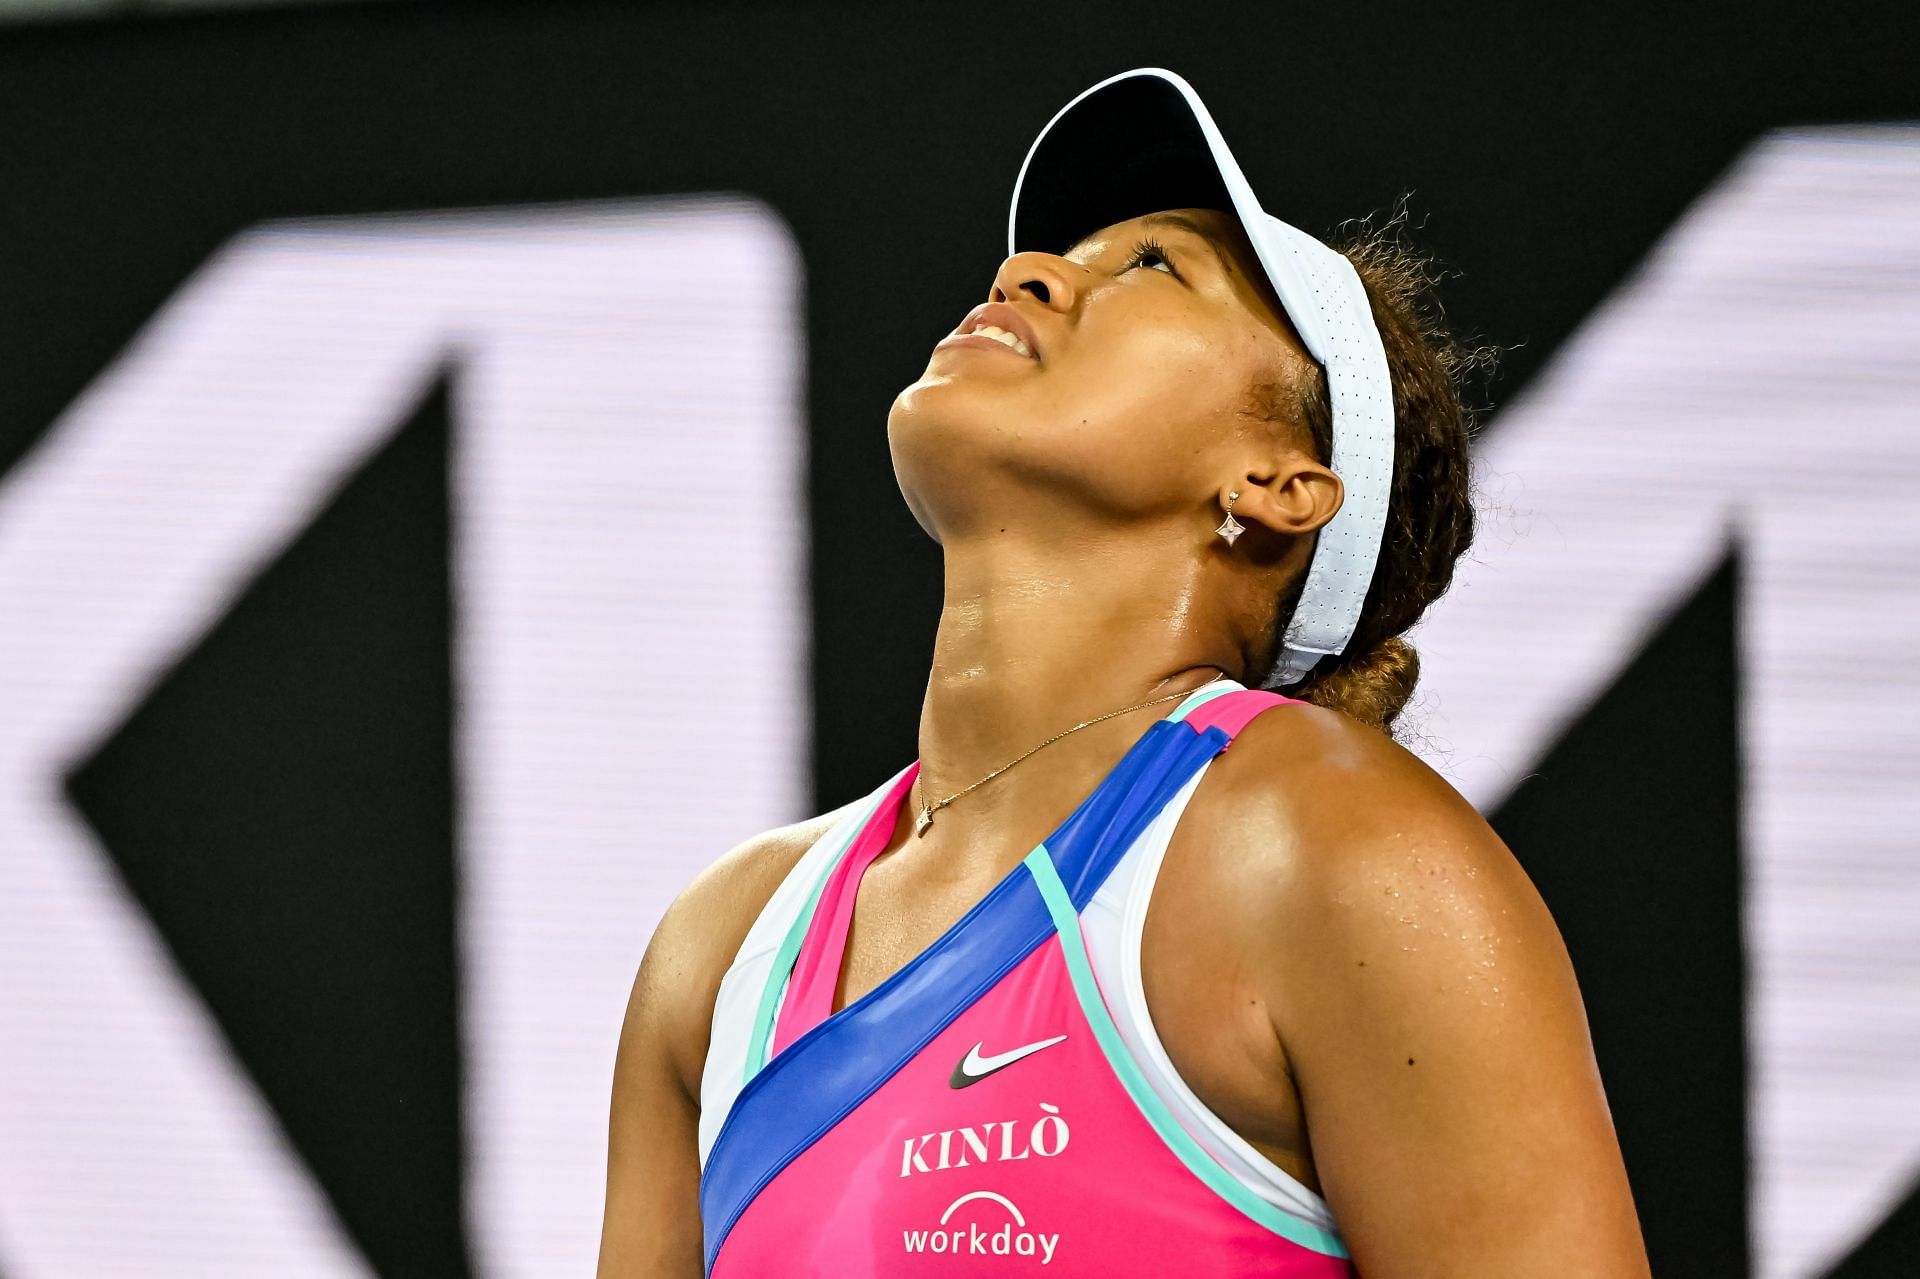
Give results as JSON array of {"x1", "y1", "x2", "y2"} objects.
[{"x1": 1025, "y1": 843, "x2": 1348, "y2": 1256}]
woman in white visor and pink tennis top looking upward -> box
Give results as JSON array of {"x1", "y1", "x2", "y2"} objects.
[{"x1": 601, "y1": 69, "x2": 1647, "y2": 1279}]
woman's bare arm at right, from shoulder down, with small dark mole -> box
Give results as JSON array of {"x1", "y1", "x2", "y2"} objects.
[{"x1": 1263, "y1": 710, "x2": 1649, "y2": 1279}]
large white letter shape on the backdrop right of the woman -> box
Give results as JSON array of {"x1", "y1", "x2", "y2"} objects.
[{"x1": 1413, "y1": 127, "x2": 1920, "y2": 1279}]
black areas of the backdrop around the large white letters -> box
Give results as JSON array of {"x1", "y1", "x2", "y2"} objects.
[{"x1": 0, "y1": 0, "x2": 1920, "y2": 1279}]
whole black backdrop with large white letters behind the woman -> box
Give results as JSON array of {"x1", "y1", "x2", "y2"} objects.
[{"x1": 0, "y1": 0, "x2": 1920, "y2": 1279}]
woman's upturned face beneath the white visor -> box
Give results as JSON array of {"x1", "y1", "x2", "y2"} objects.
[{"x1": 887, "y1": 209, "x2": 1308, "y2": 540}]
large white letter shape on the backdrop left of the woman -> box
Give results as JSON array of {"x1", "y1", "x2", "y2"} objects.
[{"x1": 0, "y1": 198, "x2": 810, "y2": 1279}]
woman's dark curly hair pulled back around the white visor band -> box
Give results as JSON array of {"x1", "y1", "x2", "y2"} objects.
[{"x1": 1242, "y1": 196, "x2": 1500, "y2": 734}]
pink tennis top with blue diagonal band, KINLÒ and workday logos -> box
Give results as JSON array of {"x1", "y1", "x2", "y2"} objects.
[{"x1": 701, "y1": 680, "x2": 1356, "y2": 1279}]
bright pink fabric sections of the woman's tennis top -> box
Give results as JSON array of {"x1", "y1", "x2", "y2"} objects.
[{"x1": 710, "y1": 689, "x2": 1356, "y2": 1279}]
